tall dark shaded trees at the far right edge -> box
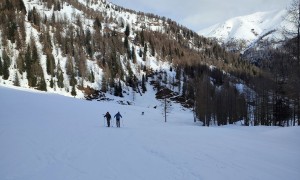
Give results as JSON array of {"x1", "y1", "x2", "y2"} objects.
[{"x1": 248, "y1": 37, "x2": 300, "y2": 126}]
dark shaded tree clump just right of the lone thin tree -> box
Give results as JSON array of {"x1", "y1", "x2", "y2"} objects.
[{"x1": 185, "y1": 66, "x2": 249, "y2": 126}]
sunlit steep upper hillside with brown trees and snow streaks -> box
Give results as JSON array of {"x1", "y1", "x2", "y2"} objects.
[{"x1": 0, "y1": 0, "x2": 258, "y2": 98}]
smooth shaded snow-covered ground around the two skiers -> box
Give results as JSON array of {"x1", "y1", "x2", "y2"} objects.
[{"x1": 0, "y1": 86, "x2": 300, "y2": 180}]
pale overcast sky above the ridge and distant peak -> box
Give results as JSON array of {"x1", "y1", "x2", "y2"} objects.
[{"x1": 108, "y1": 0, "x2": 291, "y2": 32}]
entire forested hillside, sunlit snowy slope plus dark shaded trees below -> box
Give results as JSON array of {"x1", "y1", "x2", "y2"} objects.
[{"x1": 0, "y1": 0, "x2": 300, "y2": 126}]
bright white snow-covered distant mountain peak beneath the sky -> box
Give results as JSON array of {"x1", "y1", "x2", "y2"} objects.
[{"x1": 198, "y1": 10, "x2": 290, "y2": 44}]
